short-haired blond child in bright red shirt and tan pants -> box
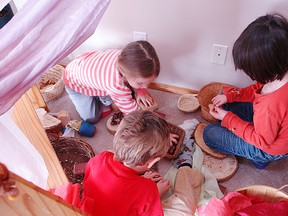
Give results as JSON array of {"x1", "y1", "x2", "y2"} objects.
[{"x1": 79, "y1": 111, "x2": 203, "y2": 216}]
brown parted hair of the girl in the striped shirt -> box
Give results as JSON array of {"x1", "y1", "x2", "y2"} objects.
[{"x1": 118, "y1": 41, "x2": 160, "y2": 78}]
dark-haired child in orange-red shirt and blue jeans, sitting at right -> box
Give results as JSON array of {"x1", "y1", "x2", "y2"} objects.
[{"x1": 203, "y1": 14, "x2": 288, "y2": 169}]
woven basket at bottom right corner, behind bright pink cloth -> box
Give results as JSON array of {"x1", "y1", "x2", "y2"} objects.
[{"x1": 237, "y1": 185, "x2": 288, "y2": 203}]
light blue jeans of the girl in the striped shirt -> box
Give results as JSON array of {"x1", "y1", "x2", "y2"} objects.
[{"x1": 65, "y1": 86, "x2": 112, "y2": 124}]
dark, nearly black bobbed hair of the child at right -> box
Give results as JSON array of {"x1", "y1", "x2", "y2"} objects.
[{"x1": 232, "y1": 13, "x2": 288, "y2": 84}]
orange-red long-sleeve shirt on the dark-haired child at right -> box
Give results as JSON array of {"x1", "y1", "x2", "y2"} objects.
[{"x1": 221, "y1": 83, "x2": 288, "y2": 155}]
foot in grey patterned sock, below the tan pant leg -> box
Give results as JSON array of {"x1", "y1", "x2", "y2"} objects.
[{"x1": 172, "y1": 139, "x2": 194, "y2": 169}]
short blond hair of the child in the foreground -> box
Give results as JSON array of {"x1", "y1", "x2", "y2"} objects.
[{"x1": 113, "y1": 111, "x2": 170, "y2": 165}]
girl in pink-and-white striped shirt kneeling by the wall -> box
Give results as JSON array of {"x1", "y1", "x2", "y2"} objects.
[{"x1": 64, "y1": 41, "x2": 160, "y2": 124}]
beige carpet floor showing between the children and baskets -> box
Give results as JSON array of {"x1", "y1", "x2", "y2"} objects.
[{"x1": 47, "y1": 89, "x2": 288, "y2": 192}]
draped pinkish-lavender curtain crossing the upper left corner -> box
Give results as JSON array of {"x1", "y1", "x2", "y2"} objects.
[{"x1": 0, "y1": 0, "x2": 110, "y2": 115}]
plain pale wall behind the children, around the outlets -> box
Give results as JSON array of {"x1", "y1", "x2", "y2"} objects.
[{"x1": 15, "y1": 0, "x2": 288, "y2": 90}]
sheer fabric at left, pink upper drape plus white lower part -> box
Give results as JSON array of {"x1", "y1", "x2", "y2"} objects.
[{"x1": 0, "y1": 0, "x2": 110, "y2": 188}]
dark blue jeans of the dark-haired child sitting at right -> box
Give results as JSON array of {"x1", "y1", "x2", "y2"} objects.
[{"x1": 203, "y1": 102, "x2": 288, "y2": 169}]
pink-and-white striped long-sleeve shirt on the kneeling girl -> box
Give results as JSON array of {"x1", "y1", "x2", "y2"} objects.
[{"x1": 64, "y1": 50, "x2": 140, "y2": 114}]
